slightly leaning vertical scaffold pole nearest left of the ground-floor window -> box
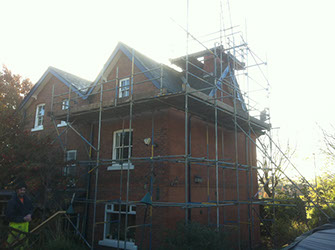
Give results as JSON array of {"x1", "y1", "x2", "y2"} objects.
[{"x1": 91, "y1": 78, "x2": 103, "y2": 250}]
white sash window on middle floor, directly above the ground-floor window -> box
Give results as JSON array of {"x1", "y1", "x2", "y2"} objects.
[{"x1": 107, "y1": 129, "x2": 134, "y2": 170}]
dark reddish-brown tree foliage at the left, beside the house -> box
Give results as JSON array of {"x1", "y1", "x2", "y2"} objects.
[{"x1": 0, "y1": 66, "x2": 70, "y2": 219}]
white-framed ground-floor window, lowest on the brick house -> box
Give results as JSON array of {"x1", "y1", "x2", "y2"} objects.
[{"x1": 99, "y1": 204, "x2": 137, "y2": 249}]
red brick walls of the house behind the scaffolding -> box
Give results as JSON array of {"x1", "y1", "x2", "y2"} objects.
[{"x1": 22, "y1": 49, "x2": 259, "y2": 249}]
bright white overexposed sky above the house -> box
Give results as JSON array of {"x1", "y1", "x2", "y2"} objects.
[{"x1": 0, "y1": 0, "x2": 335, "y2": 178}]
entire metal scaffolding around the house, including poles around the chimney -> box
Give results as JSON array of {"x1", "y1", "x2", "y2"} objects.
[{"x1": 45, "y1": 2, "x2": 335, "y2": 249}]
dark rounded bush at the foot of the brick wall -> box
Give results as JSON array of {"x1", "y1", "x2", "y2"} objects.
[{"x1": 161, "y1": 222, "x2": 233, "y2": 250}]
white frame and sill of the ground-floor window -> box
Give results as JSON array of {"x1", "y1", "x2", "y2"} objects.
[{"x1": 99, "y1": 204, "x2": 137, "y2": 250}]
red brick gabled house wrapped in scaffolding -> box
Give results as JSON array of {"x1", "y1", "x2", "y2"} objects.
[{"x1": 20, "y1": 43, "x2": 269, "y2": 249}]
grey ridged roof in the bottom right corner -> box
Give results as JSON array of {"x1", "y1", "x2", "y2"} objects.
[{"x1": 284, "y1": 223, "x2": 335, "y2": 250}]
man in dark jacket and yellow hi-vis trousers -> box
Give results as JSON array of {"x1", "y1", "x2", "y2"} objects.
[{"x1": 6, "y1": 182, "x2": 33, "y2": 249}]
